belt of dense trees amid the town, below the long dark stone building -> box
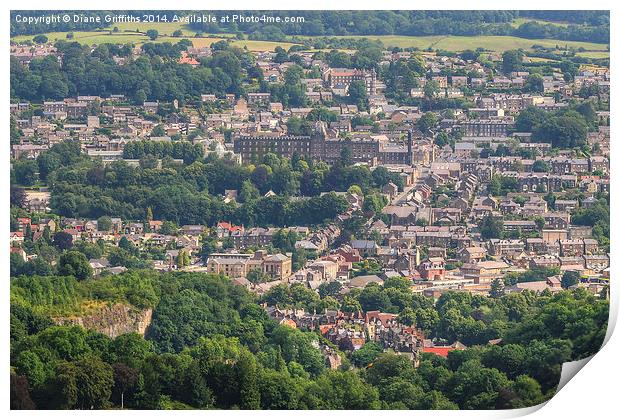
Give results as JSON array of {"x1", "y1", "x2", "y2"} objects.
[{"x1": 12, "y1": 141, "x2": 402, "y2": 228}]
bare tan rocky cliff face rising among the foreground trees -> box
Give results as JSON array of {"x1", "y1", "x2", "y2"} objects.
[{"x1": 54, "y1": 303, "x2": 153, "y2": 338}]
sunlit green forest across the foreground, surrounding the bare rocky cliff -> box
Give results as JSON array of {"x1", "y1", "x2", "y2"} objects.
[{"x1": 11, "y1": 271, "x2": 608, "y2": 409}]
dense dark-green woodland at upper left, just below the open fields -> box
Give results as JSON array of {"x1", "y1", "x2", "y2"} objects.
[{"x1": 11, "y1": 41, "x2": 253, "y2": 103}]
